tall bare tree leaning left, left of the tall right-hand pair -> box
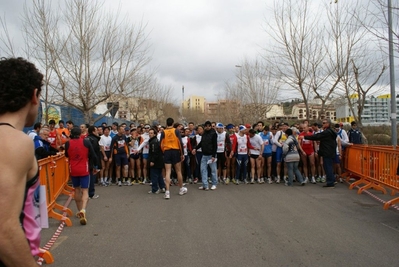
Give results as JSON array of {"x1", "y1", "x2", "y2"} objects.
[{"x1": 264, "y1": 0, "x2": 320, "y2": 119}]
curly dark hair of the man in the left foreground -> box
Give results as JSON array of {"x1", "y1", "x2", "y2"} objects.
[{"x1": 0, "y1": 57, "x2": 43, "y2": 114}]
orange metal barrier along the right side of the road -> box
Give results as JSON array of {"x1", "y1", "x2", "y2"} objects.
[{"x1": 342, "y1": 145, "x2": 399, "y2": 209}]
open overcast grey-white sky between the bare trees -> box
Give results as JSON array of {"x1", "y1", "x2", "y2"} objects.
[{"x1": 0, "y1": 0, "x2": 273, "y2": 101}]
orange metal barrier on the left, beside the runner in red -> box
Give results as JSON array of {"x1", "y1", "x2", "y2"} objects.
[{"x1": 39, "y1": 155, "x2": 73, "y2": 226}]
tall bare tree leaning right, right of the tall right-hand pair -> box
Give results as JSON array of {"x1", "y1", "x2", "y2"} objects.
[{"x1": 309, "y1": 1, "x2": 367, "y2": 119}]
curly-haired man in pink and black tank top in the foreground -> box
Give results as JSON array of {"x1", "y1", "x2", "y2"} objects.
[{"x1": 0, "y1": 58, "x2": 43, "y2": 266}]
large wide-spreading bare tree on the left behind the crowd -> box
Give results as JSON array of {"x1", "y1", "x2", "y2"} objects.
[{"x1": 25, "y1": 0, "x2": 150, "y2": 123}]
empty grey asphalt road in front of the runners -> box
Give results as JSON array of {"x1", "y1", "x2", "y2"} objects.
[{"x1": 42, "y1": 184, "x2": 399, "y2": 267}]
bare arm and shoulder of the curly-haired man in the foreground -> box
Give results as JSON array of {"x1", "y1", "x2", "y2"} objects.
[{"x1": 0, "y1": 136, "x2": 38, "y2": 267}]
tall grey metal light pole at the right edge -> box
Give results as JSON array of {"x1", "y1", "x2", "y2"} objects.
[{"x1": 388, "y1": 0, "x2": 397, "y2": 148}]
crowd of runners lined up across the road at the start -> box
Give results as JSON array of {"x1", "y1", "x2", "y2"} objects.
[{"x1": 29, "y1": 118, "x2": 362, "y2": 203}]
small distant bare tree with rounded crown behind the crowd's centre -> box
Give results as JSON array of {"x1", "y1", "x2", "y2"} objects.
[{"x1": 226, "y1": 59, "x2": 278, "y2": 123}]
